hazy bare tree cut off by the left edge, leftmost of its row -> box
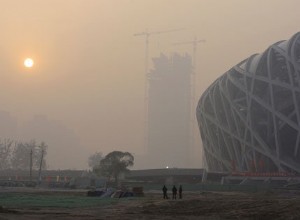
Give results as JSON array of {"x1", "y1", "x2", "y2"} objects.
[{"x1": 0, "y1": 139, "x2": 14, "y2": 170}]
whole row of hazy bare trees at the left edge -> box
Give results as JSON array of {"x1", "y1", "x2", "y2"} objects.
[{"x1": 0, "y1": 139, "x2": 48, "y2": 170}]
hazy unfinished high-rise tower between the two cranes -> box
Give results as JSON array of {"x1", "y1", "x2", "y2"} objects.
[{"x1": 147, "y1": 54, "x2": 193, "y2": 168}]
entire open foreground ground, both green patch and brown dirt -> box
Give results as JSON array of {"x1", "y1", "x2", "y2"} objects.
[{"x1": 0, "y1": 188, "x2": 300, "y2": 220}]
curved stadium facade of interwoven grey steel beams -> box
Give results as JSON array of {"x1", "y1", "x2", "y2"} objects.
[{"x1": 197, "y1": 32, "x2": 300, "y2": 173}]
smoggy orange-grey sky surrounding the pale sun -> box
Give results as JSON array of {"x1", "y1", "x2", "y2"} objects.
[{"x1": 0, "y1": 0, "x2": 300, "y2": 168}]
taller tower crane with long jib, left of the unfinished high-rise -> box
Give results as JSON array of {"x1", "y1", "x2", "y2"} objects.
[{"x1": 133, "y1": 28, "x2": 184, "y2": 153}]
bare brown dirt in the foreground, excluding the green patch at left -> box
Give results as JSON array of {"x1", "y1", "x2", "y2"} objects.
[{"x1": 0, "y1": 188, "x2": 300, "y2": 220}]
